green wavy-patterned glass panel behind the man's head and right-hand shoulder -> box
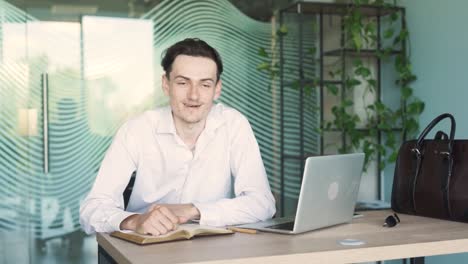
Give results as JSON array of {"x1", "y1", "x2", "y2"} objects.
[{"x1": 144, "y1": 0, "x2": 318, "y2": 203}]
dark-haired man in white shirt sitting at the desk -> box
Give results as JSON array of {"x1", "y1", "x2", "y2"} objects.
[{"x1": 80, "y1": 39, "x2": 275, "y2": 235}]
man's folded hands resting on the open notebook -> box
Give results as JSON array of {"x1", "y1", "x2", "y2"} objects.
[{"x1": 120, "y1": 204, "x2": 200, "y2": 236}]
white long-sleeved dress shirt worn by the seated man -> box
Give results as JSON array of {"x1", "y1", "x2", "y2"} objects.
[{"x1": 80, "y1": 104, "x2": 275, "y2": 233}]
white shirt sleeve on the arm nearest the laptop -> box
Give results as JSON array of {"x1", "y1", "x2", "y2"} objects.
[{"x1": 194, "y1": 112, "x2": 276, "y2": 226}]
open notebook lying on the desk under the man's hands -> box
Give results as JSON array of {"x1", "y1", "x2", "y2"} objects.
[{"x1": 111, "y1": 224, "x2": 234, "y2": 245}]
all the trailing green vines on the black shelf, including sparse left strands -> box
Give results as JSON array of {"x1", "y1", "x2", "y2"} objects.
[{"x1": 257, "y1": 0, "x2": 424, "y2": 169}]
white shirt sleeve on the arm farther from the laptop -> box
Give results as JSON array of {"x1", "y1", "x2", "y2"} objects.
[{"x1": 80, "y1": 123, "x2": 137, "y2": 234}]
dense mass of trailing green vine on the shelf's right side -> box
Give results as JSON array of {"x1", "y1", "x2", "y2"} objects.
[{"x1": 324, "y1": 0, "x2": 424, "y2": 169}]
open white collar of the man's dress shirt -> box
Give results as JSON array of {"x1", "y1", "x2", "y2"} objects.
[{"x1": 156, "y1": 104, "x2": 225, "y2": 135}]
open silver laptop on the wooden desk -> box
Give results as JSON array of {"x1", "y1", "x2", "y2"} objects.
[{"x1": 239, "y1": 153, "x2": 364, "y2": 234}]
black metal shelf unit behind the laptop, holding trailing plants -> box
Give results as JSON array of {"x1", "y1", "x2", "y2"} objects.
[{"x1": 279, "y1": 1, "x2": 405, "y2": 215}]
